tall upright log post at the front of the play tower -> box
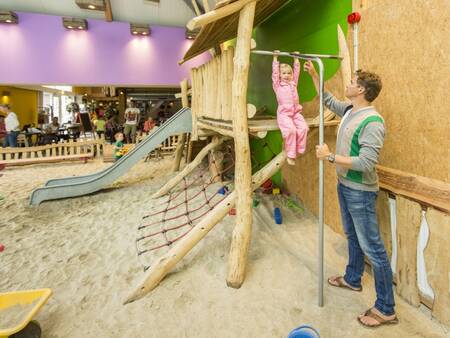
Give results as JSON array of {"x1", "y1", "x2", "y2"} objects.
[{"x1": 227, "y1": 1, "x2": 256, "y2": 288}]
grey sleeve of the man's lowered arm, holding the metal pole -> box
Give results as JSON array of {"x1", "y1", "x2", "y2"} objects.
[{"x1": 351, "y1": 122, "x2": 385, "y2": 172}]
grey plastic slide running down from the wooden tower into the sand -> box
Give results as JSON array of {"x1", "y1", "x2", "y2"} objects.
[{"x1": 30, "y1": 108, "x2": 192, "y2": 205}]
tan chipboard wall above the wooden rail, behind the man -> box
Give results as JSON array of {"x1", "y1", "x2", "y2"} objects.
[{"x1": 347, "y1": 0, "x2": 450, "y2": 182}]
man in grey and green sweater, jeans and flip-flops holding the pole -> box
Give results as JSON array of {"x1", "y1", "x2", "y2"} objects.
[{"x1": 304, "y1": 61, "x2": 398, "y2": 327}]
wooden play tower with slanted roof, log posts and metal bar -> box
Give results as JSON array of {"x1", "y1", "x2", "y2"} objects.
[{"x1": 125, "y1": 0, "x2": 340, "y2": 305}]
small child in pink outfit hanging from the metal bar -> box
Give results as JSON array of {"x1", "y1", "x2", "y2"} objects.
[{"x1": 272, "y1": 50, "x2": 309, "y2": 165}]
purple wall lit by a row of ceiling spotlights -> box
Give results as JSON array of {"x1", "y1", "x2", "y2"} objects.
[{"x1": 0, "y1": 12, "x2": 208, "y2": 86}]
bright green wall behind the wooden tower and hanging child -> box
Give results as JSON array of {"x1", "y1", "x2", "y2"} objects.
[{"x1": 248, "y1": 0, "x2": 352, "y2": 184}]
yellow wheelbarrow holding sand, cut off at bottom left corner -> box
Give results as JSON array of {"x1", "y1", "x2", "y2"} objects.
[{"x1": 0, "y1": 289, "x2": 52, "y2": 338}]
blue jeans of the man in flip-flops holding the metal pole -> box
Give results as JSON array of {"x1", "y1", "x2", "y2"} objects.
[{"x1": 338, "y1": 183, "x2": 395, "y2": 316}]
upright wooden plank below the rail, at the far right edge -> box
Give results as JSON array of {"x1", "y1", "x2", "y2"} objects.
[{"x1": 425, "y1": 208, "x2": 450, "y2": 326}]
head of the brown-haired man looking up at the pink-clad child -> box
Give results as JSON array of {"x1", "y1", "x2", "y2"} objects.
[{"x1": 345, "y1": 71, "x2": 382, "y2": 103}]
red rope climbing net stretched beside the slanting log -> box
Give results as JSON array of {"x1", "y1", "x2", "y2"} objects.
[{"x1": 136, "y1": 144, "x2": 235, "y2": 271}]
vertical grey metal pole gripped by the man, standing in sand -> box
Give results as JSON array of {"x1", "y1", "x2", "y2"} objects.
[{"x1": 314, "y1": 58, "x2": 324, "y2": 307}]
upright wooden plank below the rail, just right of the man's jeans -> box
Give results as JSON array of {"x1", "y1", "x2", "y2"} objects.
[{"x1": 396, "y1": 196, "x2": 422, "y2": 306}]
